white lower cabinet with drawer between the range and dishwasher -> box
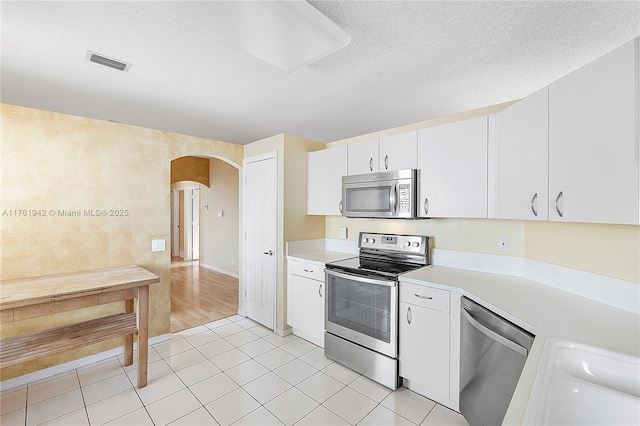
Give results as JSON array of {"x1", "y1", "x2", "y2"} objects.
[{"x1": 399, "y1": 281, "x2": 460, "y2": 410}]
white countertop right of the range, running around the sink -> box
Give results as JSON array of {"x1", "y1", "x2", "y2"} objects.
[{"x1": 400, "y1": 266, "x2": 640, "y2": 425}]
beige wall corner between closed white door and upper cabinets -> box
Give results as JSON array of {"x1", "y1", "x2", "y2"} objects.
[{"x1": 241, "y1": 134, "x2": 325, "y2": 330}]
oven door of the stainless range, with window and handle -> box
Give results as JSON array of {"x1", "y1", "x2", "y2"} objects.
[{"x1": 325, "y1": 269, "x2": 398, "y2": 358}]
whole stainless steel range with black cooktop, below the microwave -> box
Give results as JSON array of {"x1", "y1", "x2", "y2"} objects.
[{"x1": 324, "y1": 232, "x2": 429, "y2": 389}]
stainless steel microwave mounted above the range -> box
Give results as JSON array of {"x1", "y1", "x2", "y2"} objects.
[{"x1": 342, "y1": 169, "x2": 418, "y2": 219}]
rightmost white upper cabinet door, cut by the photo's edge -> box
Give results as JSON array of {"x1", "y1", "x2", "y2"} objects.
[{"x1": 549, "y1": 39, "x2": 639, "y2": 224}]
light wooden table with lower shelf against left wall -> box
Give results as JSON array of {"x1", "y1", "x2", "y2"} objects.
[{"x1": 0, "y1": 266, "x2": 160, "y2": 388}]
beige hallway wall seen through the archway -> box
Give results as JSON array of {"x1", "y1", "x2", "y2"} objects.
[{"x1": 200, "y1": 160, "x2": 240, "y2": 275}]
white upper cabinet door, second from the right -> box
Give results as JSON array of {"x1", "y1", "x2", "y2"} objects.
[{"x1": 489, "y1": 87, "x2": 549, "y2": 220}]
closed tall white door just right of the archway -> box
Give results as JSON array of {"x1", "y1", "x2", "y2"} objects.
[{"x1": 244, "y1": 153, "x2": 277, "y2": 329}]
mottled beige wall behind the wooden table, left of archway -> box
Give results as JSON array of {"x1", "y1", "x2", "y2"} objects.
[{"x1": 0, "y1": 104, "x2": 243, "y2": 380}]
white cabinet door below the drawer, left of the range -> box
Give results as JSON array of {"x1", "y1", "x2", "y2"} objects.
[{"x1": 287, "y1": 275, "x2": 324, "y2": 347}]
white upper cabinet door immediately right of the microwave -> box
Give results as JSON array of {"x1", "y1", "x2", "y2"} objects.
[{"x1": 418, "y1": 116, "x2": 487, "y2": 218}]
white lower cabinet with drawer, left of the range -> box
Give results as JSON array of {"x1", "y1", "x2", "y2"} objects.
[{"x1": 287, "y1": 260, "x2": 324, "y2": 347}]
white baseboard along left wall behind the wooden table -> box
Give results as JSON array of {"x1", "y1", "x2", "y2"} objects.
[{"x1": 0, "y1": 333, "x2": 171, "y2": 391}]
